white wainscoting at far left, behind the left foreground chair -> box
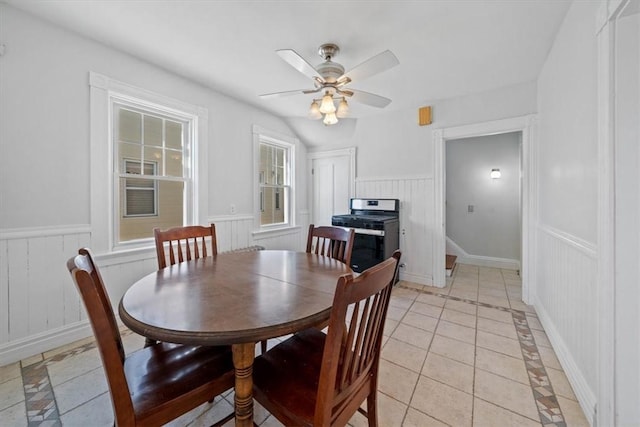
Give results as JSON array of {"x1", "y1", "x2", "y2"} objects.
[{"x1": 0, "y1": 225, "x2": 91, "y2": 366}]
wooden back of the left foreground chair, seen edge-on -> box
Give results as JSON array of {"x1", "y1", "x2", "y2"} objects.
[{"x1": 67, "y1": 248, "x2": 135, "y2": 425}]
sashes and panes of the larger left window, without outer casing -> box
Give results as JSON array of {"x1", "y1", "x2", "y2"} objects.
[{"x1": 112, "y1": 100, "x2": 192, "y2": 244}]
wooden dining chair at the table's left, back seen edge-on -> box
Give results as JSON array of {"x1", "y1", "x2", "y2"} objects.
[{"x1": 67, "y1": 248, "x2": 235, "y2": 426}]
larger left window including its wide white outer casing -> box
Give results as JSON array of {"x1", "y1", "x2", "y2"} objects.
[{"x1": 89, "y1": 72, "x2": 209, "y2": 256}]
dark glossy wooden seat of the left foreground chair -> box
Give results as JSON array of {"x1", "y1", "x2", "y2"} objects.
[{"x1": 124, "y1": 343, "x2": 235, "y2": 424}]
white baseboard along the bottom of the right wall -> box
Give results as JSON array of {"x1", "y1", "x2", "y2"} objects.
[{"x1": 534, "y1": 299, "x2": 597, "y2": 426}]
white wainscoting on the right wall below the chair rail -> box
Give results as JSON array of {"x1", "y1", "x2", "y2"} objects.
[{"x1": 534, "y1": 226, "x2": 598, "y2": 425}]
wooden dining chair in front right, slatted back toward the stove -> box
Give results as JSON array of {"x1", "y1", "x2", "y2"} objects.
[{"x1": 253, "y1": 251, "x2": 400, "y2": 426}]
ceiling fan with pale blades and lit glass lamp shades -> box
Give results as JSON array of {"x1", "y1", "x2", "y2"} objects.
[{"x1": 260, "y1": 43, "x2": 399, "y2": 125}]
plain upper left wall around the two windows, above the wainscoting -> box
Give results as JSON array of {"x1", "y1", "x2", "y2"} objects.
[{"x1": 0, "y1": 5, "x2": 306, "y2": 228}]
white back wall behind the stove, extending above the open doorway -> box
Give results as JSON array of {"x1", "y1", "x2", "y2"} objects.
[{"x1": 310, "y1": 82, "x2": 536, "y2": 284}]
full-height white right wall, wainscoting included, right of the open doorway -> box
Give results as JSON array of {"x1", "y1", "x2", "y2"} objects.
[{"x1": 535, "y1": 2, "x2": 599, "y2": 421}]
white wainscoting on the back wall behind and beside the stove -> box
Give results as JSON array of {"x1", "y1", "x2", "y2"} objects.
[{"x1": 356, "y1": 176, "x2": 436, "y2": 285}]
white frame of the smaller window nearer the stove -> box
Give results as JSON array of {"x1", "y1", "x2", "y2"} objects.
[{"x1": 252, "y1": 125, "x2": 298, "y2": 235}]
